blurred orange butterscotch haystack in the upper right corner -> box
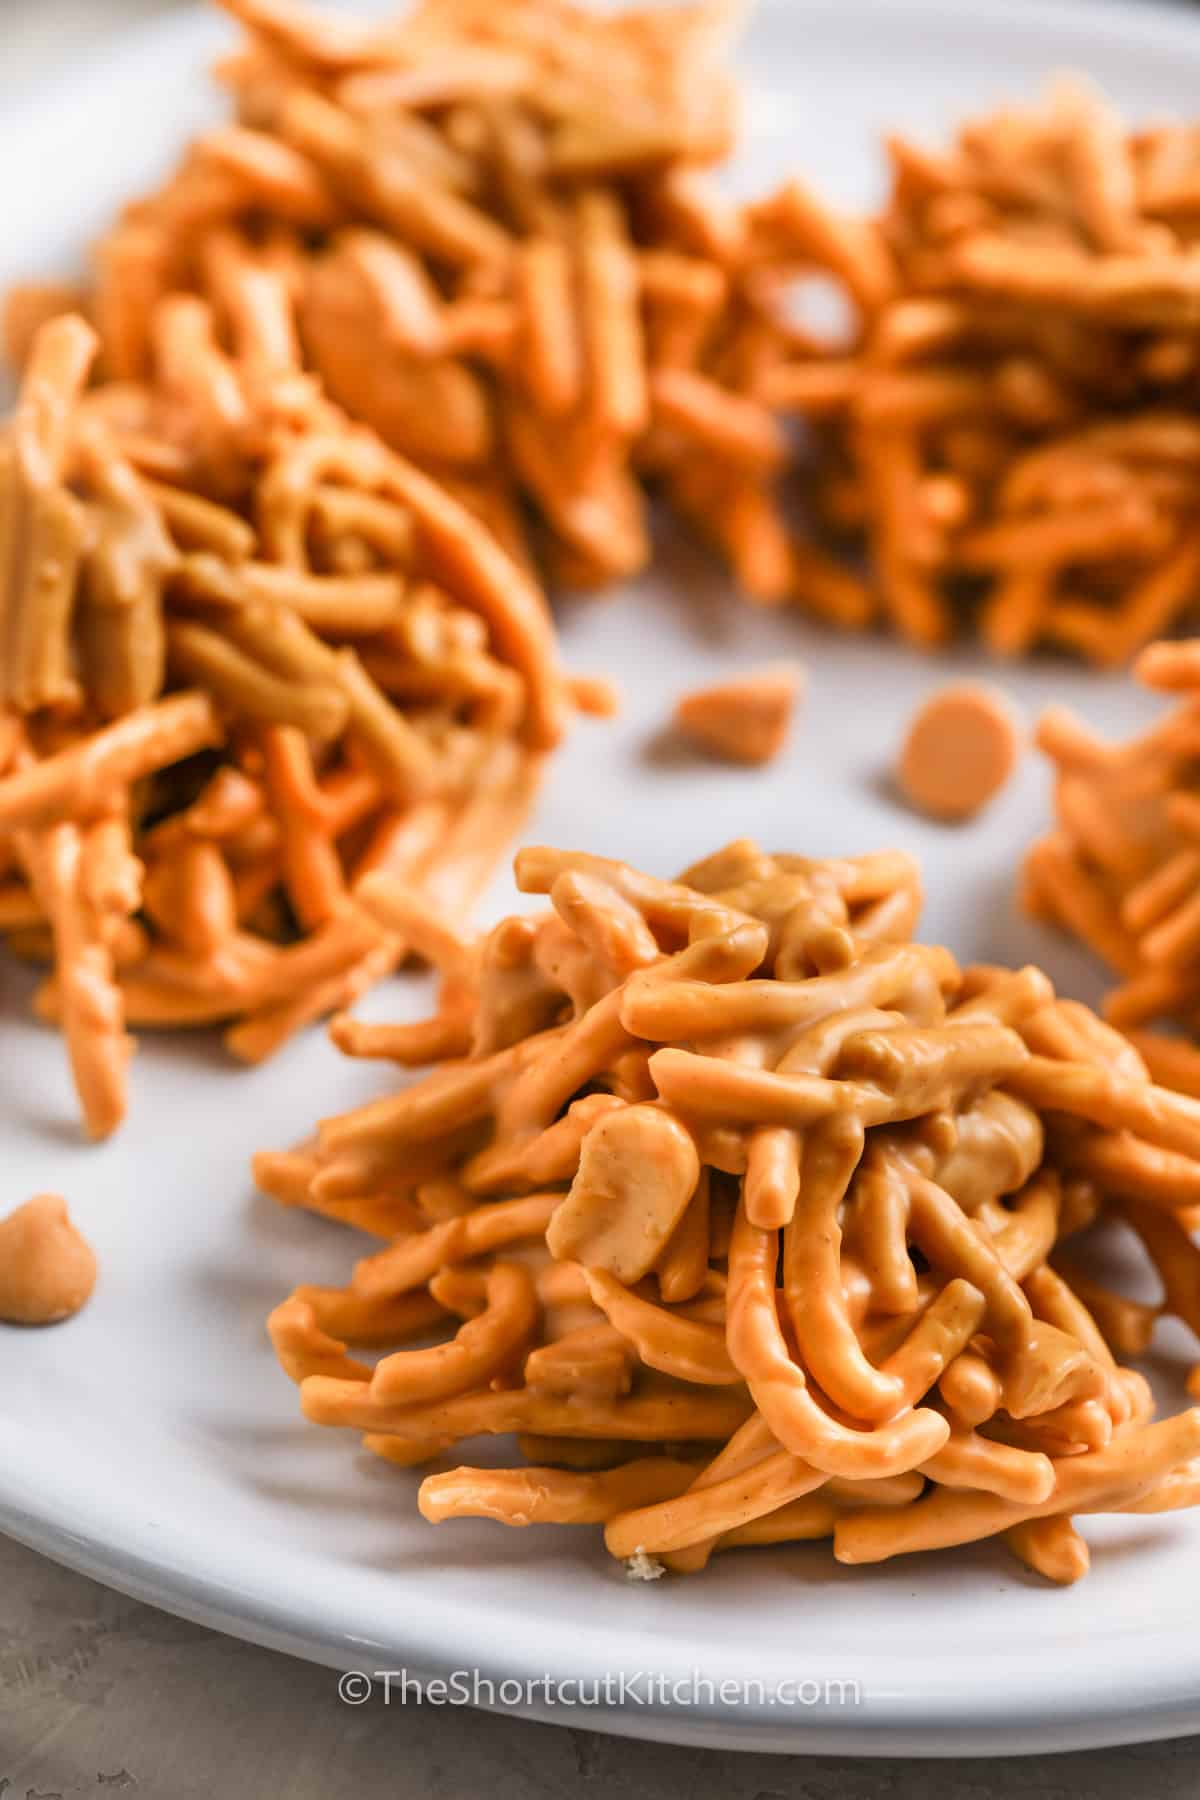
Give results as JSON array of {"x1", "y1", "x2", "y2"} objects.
[{"x1": 784, "y1": 79, "x2": 1200, "y2": 664}]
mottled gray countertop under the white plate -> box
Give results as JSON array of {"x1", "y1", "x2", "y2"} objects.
[{"x1": 0, "y1": 0, "x2": 1200, "y2": 1800}]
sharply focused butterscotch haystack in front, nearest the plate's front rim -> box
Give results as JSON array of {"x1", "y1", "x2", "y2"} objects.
[{"x1": 264, "y1": 841, "x2": 1200, "y2": 1582}]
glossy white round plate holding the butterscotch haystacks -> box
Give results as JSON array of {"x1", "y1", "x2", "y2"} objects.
[{"x1": 0, "y1": 0, "x2": 1200, "y2": 1753}]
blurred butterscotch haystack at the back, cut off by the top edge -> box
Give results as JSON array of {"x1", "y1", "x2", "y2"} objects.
[{"x1": 9, "y1": 0, "x2": 810, "y2": 599}]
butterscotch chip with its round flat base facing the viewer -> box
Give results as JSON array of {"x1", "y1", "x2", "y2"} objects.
[{"x1": 896, "y1": 682, "x2": 1024, "y2": 819}]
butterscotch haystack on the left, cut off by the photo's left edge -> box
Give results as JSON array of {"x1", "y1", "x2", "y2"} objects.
[{"x1": 0, "y1": 304, "x2": 570, "y2": 1138}]
